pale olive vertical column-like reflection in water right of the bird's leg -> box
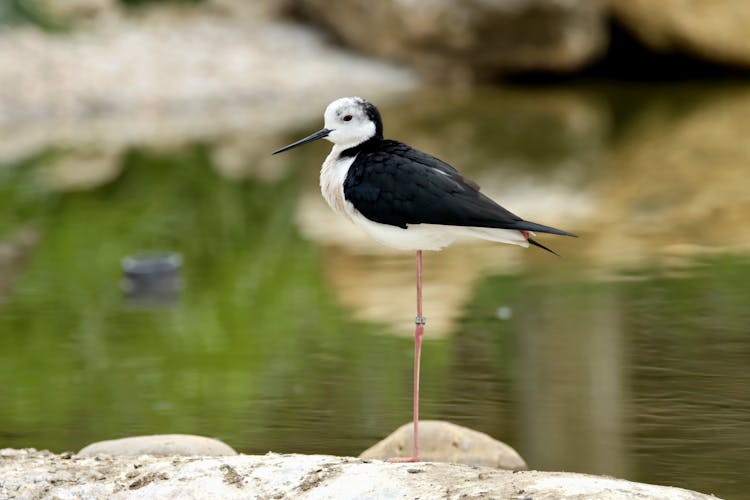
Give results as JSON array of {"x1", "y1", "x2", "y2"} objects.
[{"x1": 517, "y1": 285, "x2": 631, "y2": 477}]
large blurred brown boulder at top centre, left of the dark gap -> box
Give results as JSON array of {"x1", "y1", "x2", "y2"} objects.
[{"x1": 297, "y1": 0, "x2": 608, "y2": 80}]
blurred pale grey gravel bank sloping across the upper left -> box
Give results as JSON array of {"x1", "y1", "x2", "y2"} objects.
[{"x1": 0, "y1": 8, "x2": 417, "y2": 162}]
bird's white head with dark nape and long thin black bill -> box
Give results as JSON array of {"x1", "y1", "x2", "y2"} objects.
[{"x1": 273, "y1": 97, "x2": 383, "y2": 154}]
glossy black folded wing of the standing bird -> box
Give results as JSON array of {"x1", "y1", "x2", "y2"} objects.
[{"x1": 344, "y1": 140, "x2": 574, "y2": 236}]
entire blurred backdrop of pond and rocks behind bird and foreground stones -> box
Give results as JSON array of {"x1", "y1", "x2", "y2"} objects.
[{"x1": 0, "y1": 0, "x2": 750, "y2": 497}]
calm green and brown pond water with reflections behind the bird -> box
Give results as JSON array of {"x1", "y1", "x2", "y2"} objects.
[{"x1": 0, "y1": 85, "x2": 750, "y2": 497}]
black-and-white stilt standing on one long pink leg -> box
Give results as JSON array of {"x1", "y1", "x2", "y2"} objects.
[{"x1": 272, "y1": 97, "x2": 576, "y2": 462}]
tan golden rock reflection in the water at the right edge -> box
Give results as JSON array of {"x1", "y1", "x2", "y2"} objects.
[{"x1": 593, "y1": 87, "x2": 750, "y2": 264}]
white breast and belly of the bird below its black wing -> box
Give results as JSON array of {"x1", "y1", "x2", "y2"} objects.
[{"x1": 320, "y1": 146, "x2": 529, "y2": 250}]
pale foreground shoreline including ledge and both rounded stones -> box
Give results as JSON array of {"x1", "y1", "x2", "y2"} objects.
[{"x1": 0, "y1": 426, "x2": 715, "y2": 500}]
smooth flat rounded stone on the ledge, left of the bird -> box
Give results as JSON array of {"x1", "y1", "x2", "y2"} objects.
[{"x1": 78, "y1": 434, "x2": 237, "y2": 457}]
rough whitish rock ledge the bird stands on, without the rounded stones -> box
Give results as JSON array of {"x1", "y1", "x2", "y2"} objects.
[{"x1": 0, "y1": 449, "x2": 716, "y2": 500}]
